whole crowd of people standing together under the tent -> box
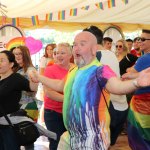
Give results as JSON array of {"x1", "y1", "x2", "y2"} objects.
[{"x1": 0, "y1": 26, "x2": 150, "y2": 150}]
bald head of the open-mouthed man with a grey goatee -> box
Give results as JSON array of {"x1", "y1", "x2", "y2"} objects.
[{"x1": 73, "y1": 31, "x2": 97, "y2": 68}]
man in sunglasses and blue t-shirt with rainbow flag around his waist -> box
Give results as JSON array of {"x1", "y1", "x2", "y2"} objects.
[{"x1": 123, "y1": 30, "x2": 150, "y2": 150}]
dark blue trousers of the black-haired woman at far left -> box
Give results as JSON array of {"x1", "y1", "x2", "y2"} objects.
[{"x1": 0, "y1": 127, "x2": 20, "y2": 150}]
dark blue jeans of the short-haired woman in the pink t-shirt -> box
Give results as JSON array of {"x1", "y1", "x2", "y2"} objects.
[{"x1": 44, "y1": 109, "x2": 66, "y2": 150}]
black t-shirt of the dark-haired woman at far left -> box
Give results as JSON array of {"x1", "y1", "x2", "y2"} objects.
[{"x1": 0, "y1": 73, "x2": 31, "y2": 116}]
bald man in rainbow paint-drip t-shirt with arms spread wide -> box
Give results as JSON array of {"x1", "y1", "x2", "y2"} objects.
[{"x1": 31, "y1": 31, "x2": 150, "y2": 150}]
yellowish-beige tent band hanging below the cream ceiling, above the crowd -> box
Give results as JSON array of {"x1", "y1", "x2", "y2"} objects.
[{"x1": 0, "y1": 17, "x2": 150, "y2": 32}]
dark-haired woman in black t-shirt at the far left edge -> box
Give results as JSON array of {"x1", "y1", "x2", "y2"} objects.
[{"x1": 0, "y1": 50, "x2": 37, "y2": 150}]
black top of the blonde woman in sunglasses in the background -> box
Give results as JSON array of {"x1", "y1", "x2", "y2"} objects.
[{"x1": 119, "y1": 54, "x2": 138, "y2": 75}]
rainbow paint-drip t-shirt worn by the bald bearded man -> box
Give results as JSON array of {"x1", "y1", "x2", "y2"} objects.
[{"x1": 63, "y1": 59, "x2": 116, "y2": 150}]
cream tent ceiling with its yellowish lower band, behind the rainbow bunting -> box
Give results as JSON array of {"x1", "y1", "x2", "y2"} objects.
[{"x1": 0, "y1": 0, "x2": 150, "y2": 31}]
